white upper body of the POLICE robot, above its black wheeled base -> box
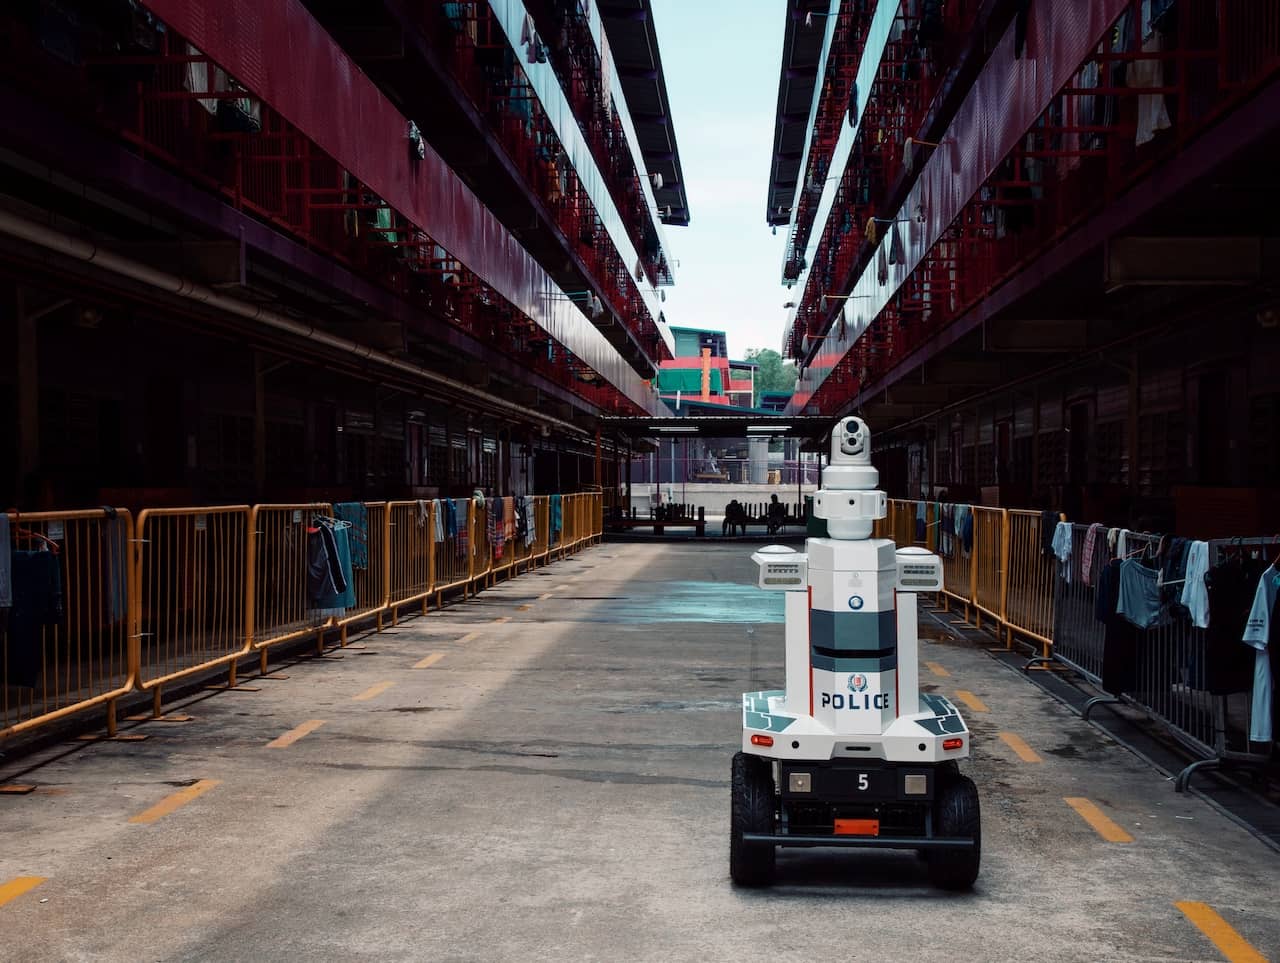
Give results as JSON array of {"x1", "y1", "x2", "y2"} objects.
[{"x1": 742, "y1": 419, "x2": 969, "y2": 763}]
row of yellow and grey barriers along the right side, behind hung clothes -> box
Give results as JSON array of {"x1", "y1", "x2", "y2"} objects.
[{"x1": 876, "y1": 499, "x2": 1270, "y2": 791}]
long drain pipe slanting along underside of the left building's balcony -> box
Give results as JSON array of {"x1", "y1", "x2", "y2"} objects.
[{"x1": 0, "y1": 210, "x2": 586, "y2": 434}]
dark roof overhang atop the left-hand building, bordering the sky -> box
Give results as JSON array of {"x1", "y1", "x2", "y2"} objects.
[{"x1": 600, "y1": 0, "x2": 689, "y2": 227}]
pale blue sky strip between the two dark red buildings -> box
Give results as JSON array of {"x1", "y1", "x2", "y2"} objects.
[{"x1": 652, "y1": 0, "x2": 788, "y2": 359}]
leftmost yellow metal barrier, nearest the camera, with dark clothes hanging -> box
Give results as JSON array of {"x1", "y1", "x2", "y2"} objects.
[{"x1": 0, "y1": 508, "x2": 138, "y2": 739}]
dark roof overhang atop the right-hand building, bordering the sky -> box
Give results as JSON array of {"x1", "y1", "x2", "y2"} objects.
[{"x1": 765, "y1": 0, "x2": 831, "y2": 225}]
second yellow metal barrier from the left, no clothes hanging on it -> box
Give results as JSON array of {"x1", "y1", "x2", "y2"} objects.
[{"x1": 134, "y1": 505, "x2": 251, "y2": 716}]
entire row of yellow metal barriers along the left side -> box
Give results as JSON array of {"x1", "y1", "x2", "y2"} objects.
[{"x1": 0, "y1": 492, "x2": 603, "y2": 740}]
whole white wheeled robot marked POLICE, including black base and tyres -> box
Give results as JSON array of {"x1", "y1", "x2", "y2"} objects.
[{"x1": 730, "y1": 417, "x2": 982, "y2": 890}]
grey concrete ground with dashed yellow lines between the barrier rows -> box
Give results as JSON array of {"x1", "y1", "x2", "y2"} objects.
[{"x1": 0, "y1": 543, "x2": 1280, "y2": 962}]
